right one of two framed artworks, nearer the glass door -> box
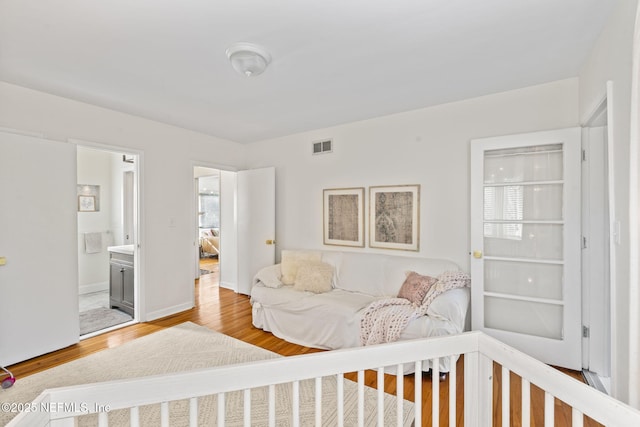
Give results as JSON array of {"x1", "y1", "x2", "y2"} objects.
[{"x1": 369, "y1": 185, "x2": 420, "y2": 251}]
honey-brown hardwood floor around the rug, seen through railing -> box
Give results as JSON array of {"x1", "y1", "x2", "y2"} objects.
[{"x1": 9, "y1": 258, "x2": 599, "y2": 427}]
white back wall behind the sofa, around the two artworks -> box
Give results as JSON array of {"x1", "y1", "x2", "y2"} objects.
[{"x1": 249, "y1": 79, "x2": 578, "y2": 270}]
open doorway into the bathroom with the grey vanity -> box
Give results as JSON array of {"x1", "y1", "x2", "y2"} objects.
[{"x1": 77, "y1": 145, "x2": 138, "y2": 339}]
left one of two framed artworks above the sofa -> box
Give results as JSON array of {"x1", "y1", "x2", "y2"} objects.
[{"x1": 323, "y1": 187, "x2": 364, "y2": 248}]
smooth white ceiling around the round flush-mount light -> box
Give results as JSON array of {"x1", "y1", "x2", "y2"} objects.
[{"x1": 0, "y1": 0, "x2": 616, "y2": 143}]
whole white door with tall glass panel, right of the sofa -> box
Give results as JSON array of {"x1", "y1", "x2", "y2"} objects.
[{"x1": 471, "y1": 128, "x2": 582, "y2": 370}]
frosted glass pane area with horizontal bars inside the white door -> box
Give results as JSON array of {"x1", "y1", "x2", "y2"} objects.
[{"x1": 483, "y1": 144, "x2": 564, "y2": 339}]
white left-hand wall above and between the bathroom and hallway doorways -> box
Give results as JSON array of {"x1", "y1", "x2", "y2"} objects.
[{"x1": 0, "y1": 82, "x2": 246, "y2": 320}]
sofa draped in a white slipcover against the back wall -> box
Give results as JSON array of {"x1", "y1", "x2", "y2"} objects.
[{"x1": 251, "y1": 251, "x2": 469, "y2": 371}]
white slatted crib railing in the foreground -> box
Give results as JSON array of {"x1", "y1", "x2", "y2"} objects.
[{"x1": 9, "y1": 332, "x2": 640, "y2": 427}]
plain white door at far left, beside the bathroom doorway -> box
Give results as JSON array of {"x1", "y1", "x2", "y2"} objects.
[{"x1": 0, "y1": 132, "x2": 80, "y2": 365}]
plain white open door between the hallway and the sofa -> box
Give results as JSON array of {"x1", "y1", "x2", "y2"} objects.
[{"x1": 236, "y1": 167, "x2": 276, "y2": 295}]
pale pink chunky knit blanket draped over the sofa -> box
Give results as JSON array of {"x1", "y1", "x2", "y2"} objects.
[{"x1": 360, "y1": 271, "x2": 471, "y2": 345}]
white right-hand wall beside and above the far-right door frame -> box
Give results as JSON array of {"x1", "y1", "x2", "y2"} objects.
[{"x1": 580, "y1": 0, "x2": 638, "y2": 402}]
